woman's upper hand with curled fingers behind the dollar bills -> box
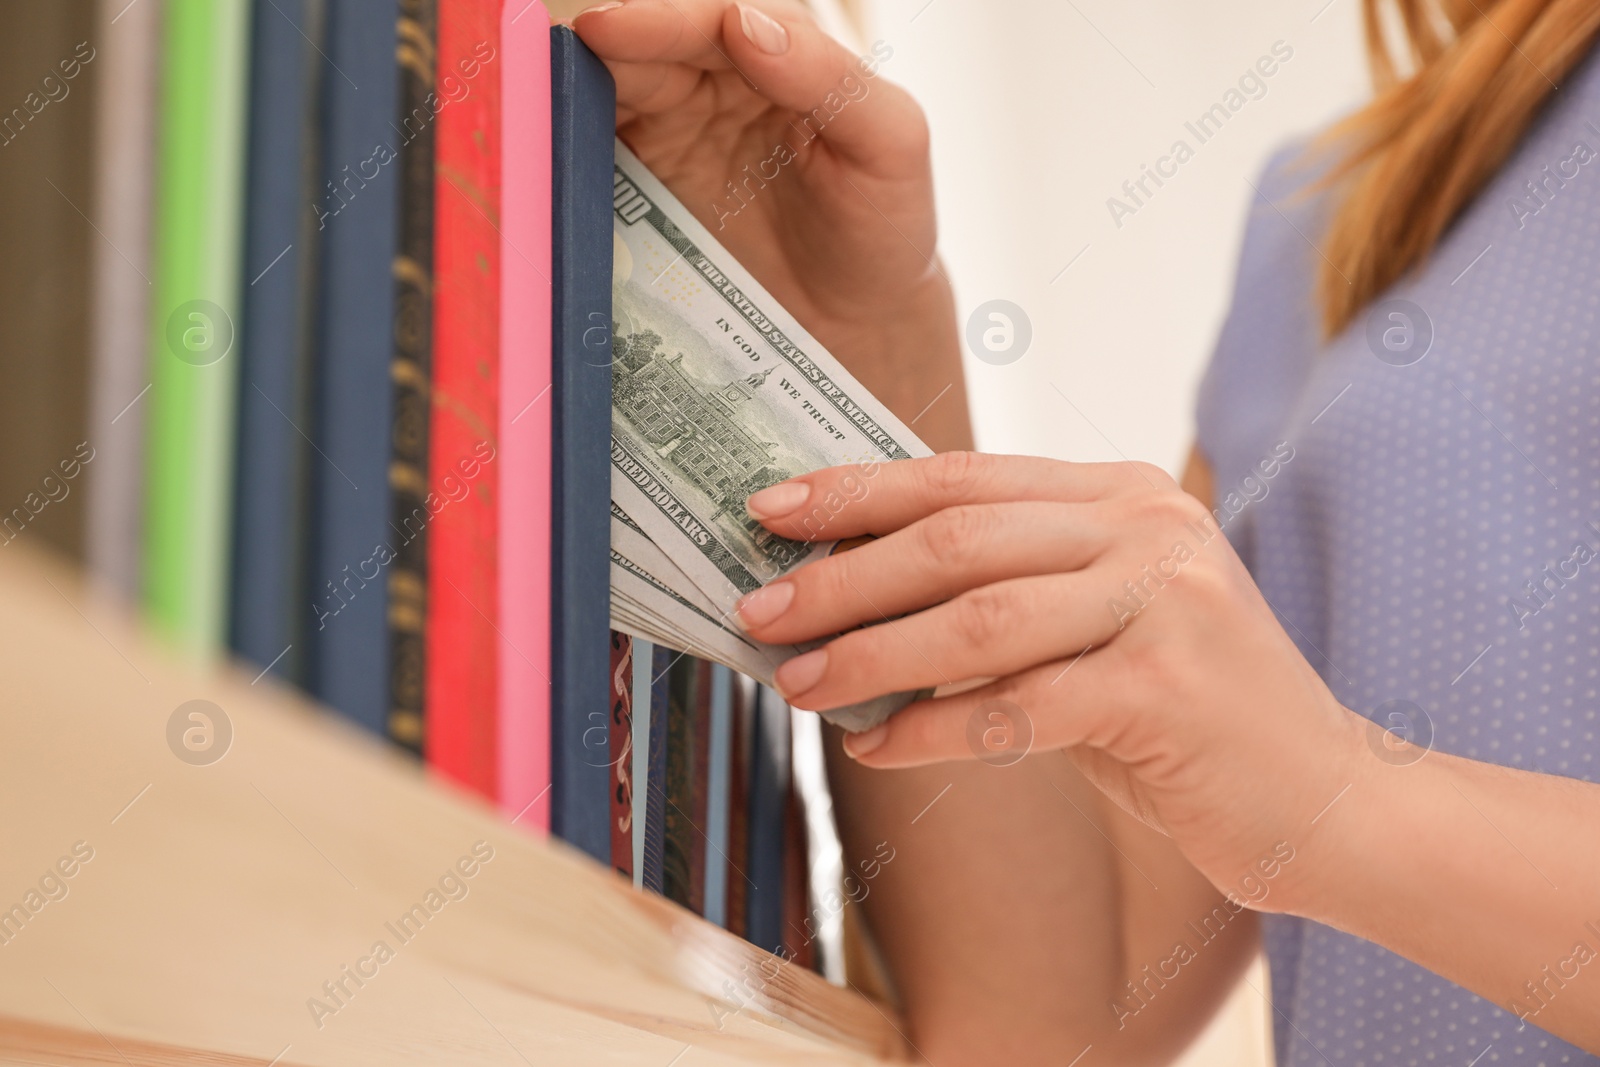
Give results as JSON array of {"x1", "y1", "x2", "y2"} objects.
[{"x1": 573, "y1": 0, "x2": 968, "y2": 448}]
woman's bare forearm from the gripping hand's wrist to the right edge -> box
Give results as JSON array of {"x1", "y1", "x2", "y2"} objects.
[{"x1": 1278, "y1": 725, "x2": 1600, "y2": 1053}]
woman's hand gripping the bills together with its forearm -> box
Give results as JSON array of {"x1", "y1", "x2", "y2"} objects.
[{"x1": 741, "y1": 454, "x2": 1600, "y2": 1051}]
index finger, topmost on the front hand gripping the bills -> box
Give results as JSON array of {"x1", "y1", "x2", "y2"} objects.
[{"x1": 746, "y1": 453, "x2": 1178, "y2": 541}]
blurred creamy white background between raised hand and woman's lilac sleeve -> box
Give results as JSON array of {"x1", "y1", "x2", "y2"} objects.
[{"x1": 859, "y1": 0, "x2": 1368, "y2": 474}]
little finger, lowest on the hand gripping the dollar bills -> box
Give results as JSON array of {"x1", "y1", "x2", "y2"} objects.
[{"x1": 845, "y1": 649, "x2": 1134, "y2": 768}]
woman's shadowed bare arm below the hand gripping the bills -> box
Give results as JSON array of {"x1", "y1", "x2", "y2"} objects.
[{"x1": 826, "y1": 447, "x2": 1258, "y2": 1067}]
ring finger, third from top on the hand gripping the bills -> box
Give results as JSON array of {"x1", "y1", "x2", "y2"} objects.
[{"x1": 773, "y1": 571, "x2": 1133, "y2": 710}]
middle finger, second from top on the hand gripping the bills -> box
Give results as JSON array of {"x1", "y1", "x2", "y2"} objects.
[{"x1": 738, "y1": 501, "x2": 1117, "y2": 645}]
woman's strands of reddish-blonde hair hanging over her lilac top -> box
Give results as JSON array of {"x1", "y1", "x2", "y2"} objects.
[{"x1": 1317, "y1": 0, "x2": 1600, "y2": 338}]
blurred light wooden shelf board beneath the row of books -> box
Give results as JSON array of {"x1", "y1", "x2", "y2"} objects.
[{"x1": 0, "y1": 544, "x2": 906, "y2": 1067}]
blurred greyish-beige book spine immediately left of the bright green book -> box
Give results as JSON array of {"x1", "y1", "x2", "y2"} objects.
[{"x1": 85, "y1": 0, "x2": 162, "y2": 603}]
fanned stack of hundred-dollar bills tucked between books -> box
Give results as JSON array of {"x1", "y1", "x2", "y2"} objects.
[{"x1": 611, "y1": 142, "x2": 931, "y2": 729}]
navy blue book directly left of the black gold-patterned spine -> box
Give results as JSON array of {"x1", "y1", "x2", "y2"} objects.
[{"x1": 302, "y1": 0, "x2": 400, "y2": 734}]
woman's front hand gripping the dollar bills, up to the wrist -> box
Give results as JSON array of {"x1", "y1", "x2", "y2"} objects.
[{"x1": 739, "y1": 453, "x2": 1370, "y2": 910}]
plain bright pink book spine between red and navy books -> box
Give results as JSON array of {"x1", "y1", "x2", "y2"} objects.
[{"x1": 496, "y1": 0, "x2": 552, "y2": 833}]
